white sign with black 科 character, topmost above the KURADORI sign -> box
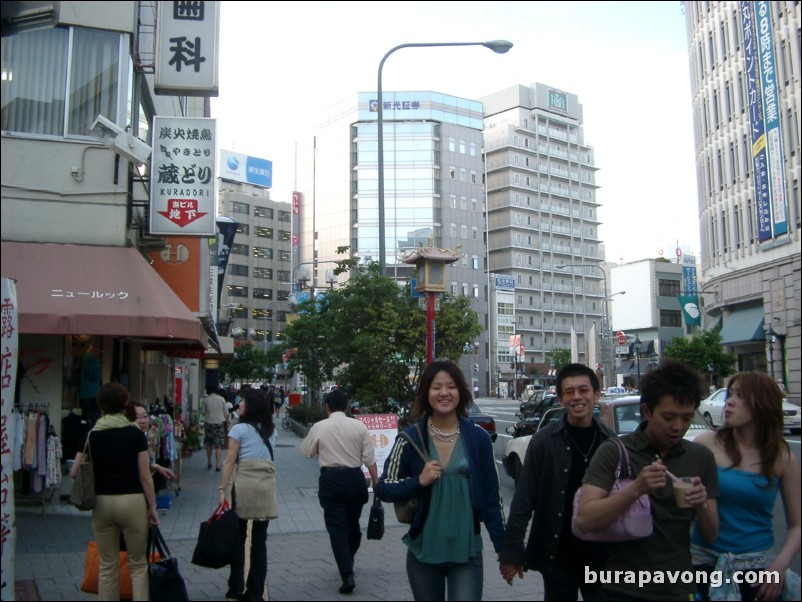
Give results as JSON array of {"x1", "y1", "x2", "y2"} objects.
[{"x1": 154, "y1": 2, "x2": 220, "y2": 96}]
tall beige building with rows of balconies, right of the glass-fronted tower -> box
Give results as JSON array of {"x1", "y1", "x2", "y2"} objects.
[{"x1": 481, "y1": 83, "x2": 610, "y2": 392}]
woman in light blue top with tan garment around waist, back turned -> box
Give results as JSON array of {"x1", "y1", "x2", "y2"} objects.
[{"x1": 218, "y1": 388, "x2": 276, "y2": 600}]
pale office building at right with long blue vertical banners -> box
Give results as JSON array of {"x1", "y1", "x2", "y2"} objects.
[{"x1": 683, "y1": 1, "x2": 802, "y2": 400}]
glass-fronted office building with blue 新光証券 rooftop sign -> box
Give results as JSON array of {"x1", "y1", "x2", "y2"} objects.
[{"x1": 299, "y1": 91, "x2": 489, "y2": 395}]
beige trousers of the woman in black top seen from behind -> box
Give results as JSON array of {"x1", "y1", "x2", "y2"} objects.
[{"x1": 92, "y1": 493, "x2": 150, "y2": 600}]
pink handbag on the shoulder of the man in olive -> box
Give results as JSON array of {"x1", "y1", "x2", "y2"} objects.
[{"x1": 571, "y1": 439, "x2": 654, "y2": 542}]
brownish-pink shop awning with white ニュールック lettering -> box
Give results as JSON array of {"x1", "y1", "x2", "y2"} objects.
[{"x1": 0, "y1": 237, "x2": 208, "y2": 348}]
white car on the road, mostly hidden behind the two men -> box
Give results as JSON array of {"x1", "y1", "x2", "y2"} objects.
[{"x1": 501, "y1": 395, "x2": 711, "y2": 482}]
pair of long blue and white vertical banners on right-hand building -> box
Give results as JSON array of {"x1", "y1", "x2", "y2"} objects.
[{"x1": 739, "y1": 1, "x2": 788, "y2": 242}]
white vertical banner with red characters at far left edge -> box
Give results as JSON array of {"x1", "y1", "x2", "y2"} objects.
[{"x1": 0, "y1": 278, "x2": 17, "y2": 600}]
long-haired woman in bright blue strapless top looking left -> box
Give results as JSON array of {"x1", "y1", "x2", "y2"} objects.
[{"x1": 691, "y1": 372, "x2": 802, "y2": 600}]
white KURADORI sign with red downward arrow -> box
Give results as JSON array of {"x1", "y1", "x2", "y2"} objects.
[{"x1": 150, "y1": 116, "x2": 217, "y2": 236}]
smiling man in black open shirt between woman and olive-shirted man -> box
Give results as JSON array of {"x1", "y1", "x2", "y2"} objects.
[{"x1": 499, "y1": 364, "x2": 615, "y2": 600}]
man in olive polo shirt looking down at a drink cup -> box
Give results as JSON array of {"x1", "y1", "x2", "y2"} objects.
[{"x1": 576, "y1": 359, "x2": 719, "y2": 600}]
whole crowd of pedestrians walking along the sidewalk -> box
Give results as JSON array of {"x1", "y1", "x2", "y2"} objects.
[{"x1": 73, "y1": 359, "x2": 802, "y2": 601}]
